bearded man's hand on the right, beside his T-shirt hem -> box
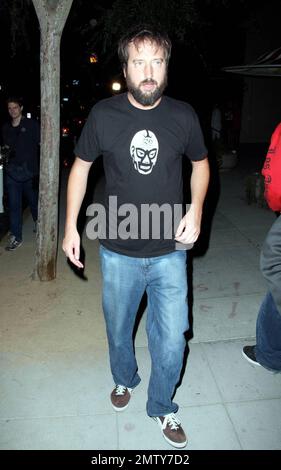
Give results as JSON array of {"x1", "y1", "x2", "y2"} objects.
[{"x1": 175, "y1": 204, "x2": 202, "y2": 244}]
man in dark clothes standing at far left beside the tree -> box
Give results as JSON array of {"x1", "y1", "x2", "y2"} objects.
[{"x1": 2, "y1": 98, "x2": 40, "y2": 251}]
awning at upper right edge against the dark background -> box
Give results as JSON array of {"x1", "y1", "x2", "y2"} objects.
[{"x1": 222, "y1": 47, "x2": 281, "y2": 77}]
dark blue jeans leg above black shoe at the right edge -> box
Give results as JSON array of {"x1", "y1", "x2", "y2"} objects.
[{"x1": 255, "y1": 292, "x2": 281, "y2": 371}]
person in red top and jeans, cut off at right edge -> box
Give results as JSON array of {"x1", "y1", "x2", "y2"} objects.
[{"x1": 243, "y1": 123, "x2": 281, "y2": 372}]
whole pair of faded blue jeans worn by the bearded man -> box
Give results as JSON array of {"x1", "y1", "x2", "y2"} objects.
[{"x1": 100, "y1": 246, "x2": 189, "y2": 416}]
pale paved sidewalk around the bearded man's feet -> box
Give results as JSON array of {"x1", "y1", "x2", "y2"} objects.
[{"x1": 0, "y1": 159, "x2": 281, "y2": 450}]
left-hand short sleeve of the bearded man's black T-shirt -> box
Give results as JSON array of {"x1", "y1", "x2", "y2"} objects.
[{"x1": 74, "y1": 107, "x2": 101, "y2": 162}]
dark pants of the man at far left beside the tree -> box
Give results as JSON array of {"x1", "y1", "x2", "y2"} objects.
[{"x1": 6, "y1": 175, "x2": 38, "y2": 241}]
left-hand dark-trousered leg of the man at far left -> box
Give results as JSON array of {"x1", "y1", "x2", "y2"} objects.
[{"x1": 6, "y1": 175, "x2": 23, "y2": 241}]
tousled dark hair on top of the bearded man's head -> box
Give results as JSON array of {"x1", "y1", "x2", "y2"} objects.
[{"x1": 118, "y1": 26, "x2": 172, "y2": 67}]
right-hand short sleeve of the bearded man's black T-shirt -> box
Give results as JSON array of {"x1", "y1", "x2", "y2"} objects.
[{"x1": 185, "y1": 107, "x2": 208, "y2": 161}]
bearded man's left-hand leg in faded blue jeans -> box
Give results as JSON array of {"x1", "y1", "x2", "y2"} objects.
[{"x1": 100, "y1": 246, "x2": 145, "y2": 388}]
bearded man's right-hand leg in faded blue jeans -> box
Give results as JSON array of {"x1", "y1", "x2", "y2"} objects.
[{"x1": 144, "y1": 251, "x2": 189, "y2": 417}]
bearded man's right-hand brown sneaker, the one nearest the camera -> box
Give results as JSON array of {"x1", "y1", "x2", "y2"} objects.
[{"x1": 153, "y1": 413, "x2": 187, "y2": 449}]
